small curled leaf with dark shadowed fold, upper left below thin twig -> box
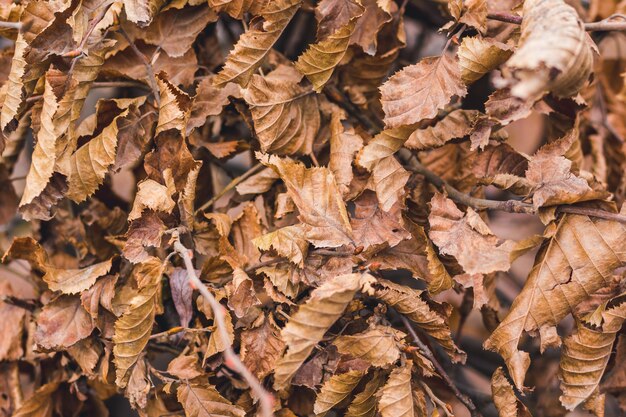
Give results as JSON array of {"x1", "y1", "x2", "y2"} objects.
[{"x1": 154, "y1": 72, "x2": 192, "y2": 136}]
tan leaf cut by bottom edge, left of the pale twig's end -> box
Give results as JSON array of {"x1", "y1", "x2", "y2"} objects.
[{"x1": 177, "y1": 382, "x2": 246, "y2": 417}]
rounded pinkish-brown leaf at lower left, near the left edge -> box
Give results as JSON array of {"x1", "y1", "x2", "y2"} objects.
[{"x1": 35, "y1": 295, "x2": 94, "y2": 349}]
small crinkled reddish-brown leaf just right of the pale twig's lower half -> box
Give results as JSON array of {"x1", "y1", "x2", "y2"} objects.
[{"x1": 241, "y1": 315, "x2": 285, "y2": 379}]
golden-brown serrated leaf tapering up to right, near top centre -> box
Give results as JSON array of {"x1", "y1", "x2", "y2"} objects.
[{"x1": 296, "y1": 19, "x2": 356, "y2": 93}]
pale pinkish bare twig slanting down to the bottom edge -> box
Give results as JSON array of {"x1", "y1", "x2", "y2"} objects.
[{"x1": 172, "y1": 231, "x2": 274, "y2": 417}]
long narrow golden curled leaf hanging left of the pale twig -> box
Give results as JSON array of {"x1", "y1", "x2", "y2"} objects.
[{"x1": 113, "y1": 258, "x2": 164, "y2": 388}]
